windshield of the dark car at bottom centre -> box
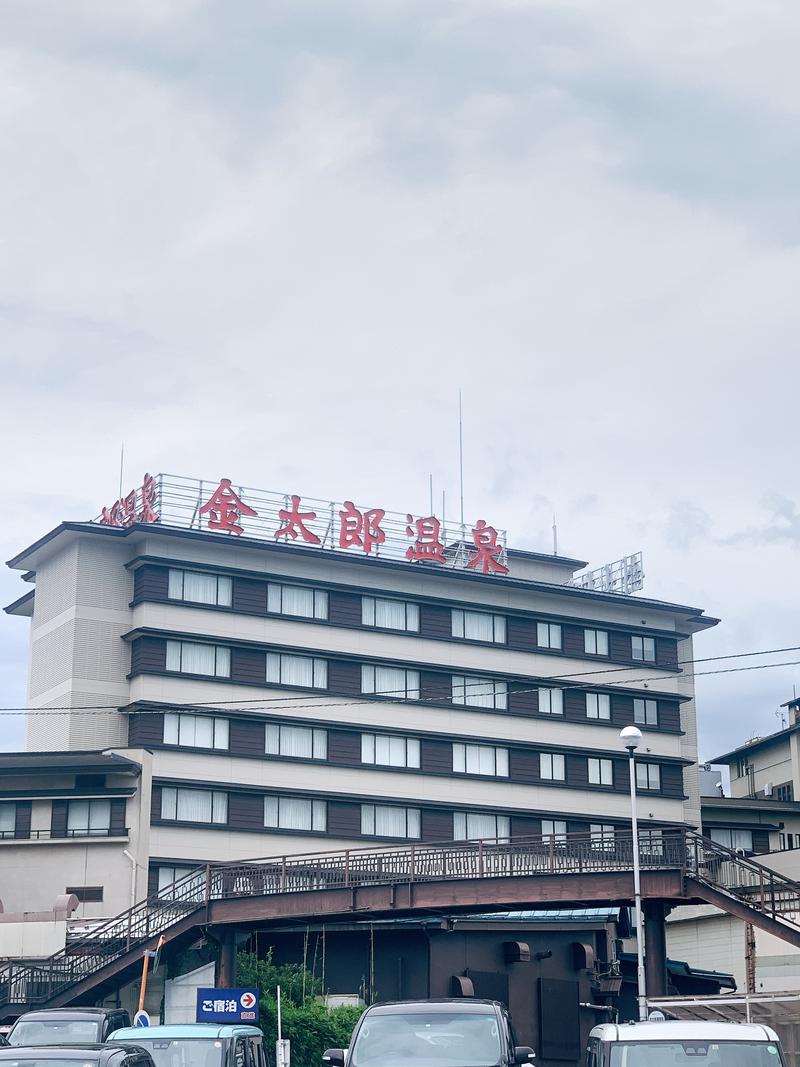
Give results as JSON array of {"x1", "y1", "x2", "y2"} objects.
[{"x1": 351, "y1": 1012, "x2": 500, "y2": 1067}]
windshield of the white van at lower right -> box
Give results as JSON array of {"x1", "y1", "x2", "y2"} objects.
[{"x1": 609, "y1": 1039, "x2": 783, "y2": 1067}]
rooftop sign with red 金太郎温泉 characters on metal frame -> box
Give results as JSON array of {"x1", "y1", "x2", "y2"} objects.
[{"x1": 95, "y1": 474, "x2": 509, "y2": 575}]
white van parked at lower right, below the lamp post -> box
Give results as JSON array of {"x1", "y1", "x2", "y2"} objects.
[{"x1": 586, "y1": 1020, "x2": 786, "y2": 1067}]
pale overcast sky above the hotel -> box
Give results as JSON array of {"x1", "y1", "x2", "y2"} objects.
[{"x1": 0, "y1": 0, "x2": 800, "y2": 758}]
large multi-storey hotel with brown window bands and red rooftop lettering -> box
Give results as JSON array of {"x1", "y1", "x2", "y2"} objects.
[{"x1": 0, "y1": 476, "x2": 717, "y2": 915}]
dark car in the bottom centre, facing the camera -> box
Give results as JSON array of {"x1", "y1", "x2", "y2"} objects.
[{"x1": 322, "y1": 999, "x2": 533, "y2": 1067}]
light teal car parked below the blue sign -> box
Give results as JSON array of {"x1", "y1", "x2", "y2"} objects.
[{"x1": 107, "y1": 1022, "x2": 269, "y2": 1067}]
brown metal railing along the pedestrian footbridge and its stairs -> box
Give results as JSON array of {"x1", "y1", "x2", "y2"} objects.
[{"x1": 0, "y1": 830, "x2": 800, "y2": 1006}]
